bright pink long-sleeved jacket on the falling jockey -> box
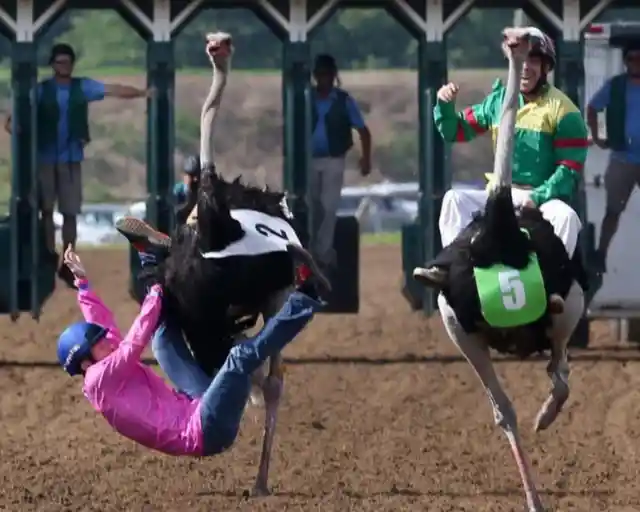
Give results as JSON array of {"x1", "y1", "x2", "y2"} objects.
[{"x1": 76, "y1": 280, "x2": 203, "y2": 456}]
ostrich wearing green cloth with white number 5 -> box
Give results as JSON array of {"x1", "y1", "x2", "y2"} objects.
[{"x1": 414, "y1": 27, "x2": 584, "y2": 512}]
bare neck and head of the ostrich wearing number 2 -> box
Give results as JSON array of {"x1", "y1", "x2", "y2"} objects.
[{"x1": 200, "y1": 32, "x2": 233, "y2": 168}]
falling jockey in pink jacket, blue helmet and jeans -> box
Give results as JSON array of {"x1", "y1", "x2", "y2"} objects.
[{"x1": 58, "y1": 247, "x2": 319, "y2": 456}]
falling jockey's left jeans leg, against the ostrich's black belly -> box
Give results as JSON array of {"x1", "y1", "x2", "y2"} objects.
[{"x1": 151, "y1": 319, "x2": 211, "y2": 398}]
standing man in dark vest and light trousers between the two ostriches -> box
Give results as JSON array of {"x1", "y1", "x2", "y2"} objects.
[{"x1": 309, "y1": 54, "x2": 371, "y2": 269}]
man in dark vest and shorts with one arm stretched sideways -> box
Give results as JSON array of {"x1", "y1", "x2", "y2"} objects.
[{"x1": 5, "y1": 44, "x2": 149, "y2": 288}]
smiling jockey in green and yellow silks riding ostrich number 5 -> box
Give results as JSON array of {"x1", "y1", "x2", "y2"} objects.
[{"x1": 416, "y1": 27, "x2": 587, "y2": 287}]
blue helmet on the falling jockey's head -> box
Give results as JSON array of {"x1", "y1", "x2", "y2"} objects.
[{"x1": 58, "y1": 322, "x2": 109, "y2": 376}]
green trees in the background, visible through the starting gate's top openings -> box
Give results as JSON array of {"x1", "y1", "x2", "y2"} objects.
[{"x1": 0, "y1": 9, "x2": 640, "y2": 69}]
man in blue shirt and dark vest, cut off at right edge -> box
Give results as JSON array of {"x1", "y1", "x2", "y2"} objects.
[{"x1": 587, "y1": 41, "x2": 640, "y2": 272}]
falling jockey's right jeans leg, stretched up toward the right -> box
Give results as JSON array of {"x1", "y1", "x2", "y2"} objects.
[{"x1": 200, "y1": 292, "x2": 321, "y2": 456}]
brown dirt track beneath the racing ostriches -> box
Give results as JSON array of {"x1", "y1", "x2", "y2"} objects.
[{"x1": 0, "y1": 247, "x2": 640, "y2": 512}]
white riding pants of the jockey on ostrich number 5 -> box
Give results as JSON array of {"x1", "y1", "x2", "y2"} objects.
[{"x1": 439, "y1": 187, "x2": 582, "y2": 258}]
